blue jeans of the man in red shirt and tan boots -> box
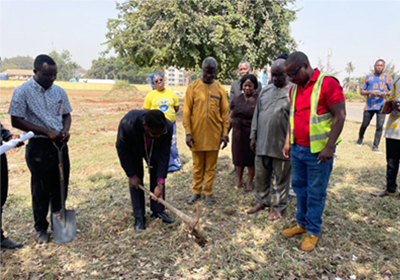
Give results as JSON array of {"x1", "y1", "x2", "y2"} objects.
[{"x1": 291, "y1": 144, "x2": 333, "y2": 236}]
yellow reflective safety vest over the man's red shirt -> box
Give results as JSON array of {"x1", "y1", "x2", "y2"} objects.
[{"x1": 290, "y1": 72, "x2": 341, "y2": 153}]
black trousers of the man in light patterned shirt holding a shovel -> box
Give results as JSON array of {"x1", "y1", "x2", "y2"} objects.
[{"x1": 25, "y1": 138, "x2": 70, "y2": 232}]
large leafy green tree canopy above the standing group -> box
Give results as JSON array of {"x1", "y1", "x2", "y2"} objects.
[{"x1": 106, "y1": 0, "x2": 296, "y2": 78}]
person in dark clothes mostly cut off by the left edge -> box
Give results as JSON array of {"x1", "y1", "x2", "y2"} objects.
[{"x1": 0, "y1": 123, "x2": 24, "y2": 249}]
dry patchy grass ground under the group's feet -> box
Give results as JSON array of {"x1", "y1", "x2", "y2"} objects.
[{"x1": 0, "y1": 92, "x2": 400, "y2": 279}]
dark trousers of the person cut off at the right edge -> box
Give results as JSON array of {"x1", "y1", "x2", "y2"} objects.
[{"x1": 386, "y1": 138, "x2": 400, "y2": 193}]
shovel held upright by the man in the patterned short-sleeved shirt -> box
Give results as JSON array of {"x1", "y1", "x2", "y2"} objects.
[{"x1": 51, "y1": 142, "x2": 76, "y2": 244}]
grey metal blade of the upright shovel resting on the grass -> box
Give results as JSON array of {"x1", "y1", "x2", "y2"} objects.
[{"x1": 52, "y1": 210, "x2": 76, "y2": 244}]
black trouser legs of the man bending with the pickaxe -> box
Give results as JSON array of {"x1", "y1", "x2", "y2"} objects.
[{"x1": 129, "y1": 161, "x2": 165, "y2": 218}]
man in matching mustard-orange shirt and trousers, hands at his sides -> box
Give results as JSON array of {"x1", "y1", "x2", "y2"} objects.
[{"x1": 183, "y1": 57, "x2": 229, "y2": 205}]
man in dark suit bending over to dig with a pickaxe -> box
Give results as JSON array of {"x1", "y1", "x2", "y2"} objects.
[{"x1": 116, "y1": 110, "x2": 175, "y2": 232}]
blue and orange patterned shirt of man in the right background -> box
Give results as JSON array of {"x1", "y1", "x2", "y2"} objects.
[{"x1": 362, "y1": 73, "x2": 393, "y2": 111}]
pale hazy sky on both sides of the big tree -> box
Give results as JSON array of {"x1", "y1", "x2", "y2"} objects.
[{"x1": 0, "y1": 0, "x2": 400, "y2": 80}]
